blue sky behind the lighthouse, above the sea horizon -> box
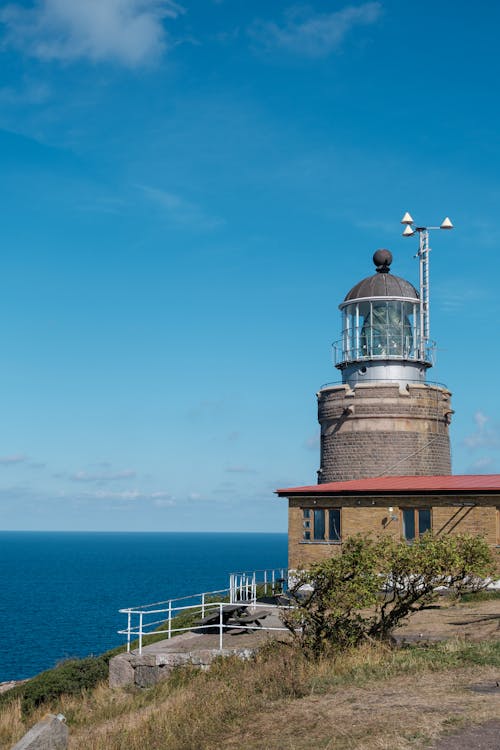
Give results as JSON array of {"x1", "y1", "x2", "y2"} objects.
[{"x1": 0, "y1": 0, "x2": 500, "y2": 531}]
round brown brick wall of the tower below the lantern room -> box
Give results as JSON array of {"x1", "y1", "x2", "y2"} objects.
[{"x1": 318, "y1": 383, "x2": 451, "y2": 484}]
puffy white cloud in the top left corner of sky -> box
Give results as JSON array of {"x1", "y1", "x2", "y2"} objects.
[{"x1": 0, "y1": 0, "x2": 184, "y2": 67}]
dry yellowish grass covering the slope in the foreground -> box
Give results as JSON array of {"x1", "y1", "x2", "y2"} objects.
[{"x1": 0, "y1": 602, "x2": 500, "y2": 750}]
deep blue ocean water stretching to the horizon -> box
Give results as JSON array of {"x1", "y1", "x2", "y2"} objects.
[{"x1": 0, "y1": 531, "x2": 287, "y2": 682}]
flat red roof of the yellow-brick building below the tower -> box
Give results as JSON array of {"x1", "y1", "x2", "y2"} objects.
[{"x1": 275, "y1": 474, "x2": 500, "y2": 497}]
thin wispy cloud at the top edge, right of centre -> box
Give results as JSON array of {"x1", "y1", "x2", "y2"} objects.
[{"x1": 249, "y1": 2, "x2": 382, "y2": 58}]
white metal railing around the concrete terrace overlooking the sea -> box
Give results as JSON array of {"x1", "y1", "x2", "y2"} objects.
[{"x1": 118, "y1": 568, "x2": 288, "y2": 654}]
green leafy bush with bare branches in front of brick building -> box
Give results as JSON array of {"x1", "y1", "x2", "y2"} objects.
[{"x1": 283, "y1": 534, "x2": 494, "y2": 656}]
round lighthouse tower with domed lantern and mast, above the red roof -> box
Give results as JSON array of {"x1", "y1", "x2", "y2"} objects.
[{"x1": 317, "y1": 220, "x2": 453, "y2": 484}]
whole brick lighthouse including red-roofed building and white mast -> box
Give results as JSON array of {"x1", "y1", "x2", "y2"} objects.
[{"x1": 276, "y1": 214, "x2": 500, "y2": 570}]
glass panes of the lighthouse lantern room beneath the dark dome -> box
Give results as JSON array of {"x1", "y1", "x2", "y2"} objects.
[{"x1": 342, "y1": 299, "x2": 421, "y2": 362}]
